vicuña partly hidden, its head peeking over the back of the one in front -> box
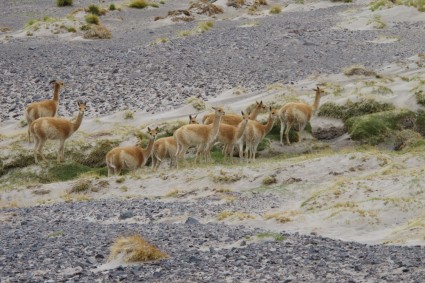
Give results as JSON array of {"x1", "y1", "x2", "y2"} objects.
[{"x1": 152, "y1": 115, "x2": 198, "y2": 171}]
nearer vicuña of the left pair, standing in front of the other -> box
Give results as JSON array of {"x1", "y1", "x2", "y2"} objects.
[{"x1": 30, "y1": 101, "x2": 86, "y2": 163}]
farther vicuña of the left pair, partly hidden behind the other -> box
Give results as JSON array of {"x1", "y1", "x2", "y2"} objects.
[{"x1": 25, "y1": 80, "x2": 63, "y2": 142}]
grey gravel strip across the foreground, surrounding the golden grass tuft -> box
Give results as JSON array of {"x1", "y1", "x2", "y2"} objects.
[{"x1": 0, "y1": 200, "x2": 425, "y2": 282}]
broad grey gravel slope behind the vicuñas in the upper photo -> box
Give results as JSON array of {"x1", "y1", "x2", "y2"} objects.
[{"x1": 0, "y1": 1, "x2": 425, "y2": 120}]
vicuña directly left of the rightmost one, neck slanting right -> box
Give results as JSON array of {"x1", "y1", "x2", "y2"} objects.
[{"x1": 239, "y1": 107, "x2": 278, "y2": 161}]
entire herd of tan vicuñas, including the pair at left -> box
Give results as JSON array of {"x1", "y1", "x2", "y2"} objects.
[{"x1": 25, "y1": 80, "x2": 323, "y2": 176}]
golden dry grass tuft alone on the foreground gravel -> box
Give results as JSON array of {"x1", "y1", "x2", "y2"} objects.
[{"x1": 109, "y1": 235, "x2": 169, "y2": 262}]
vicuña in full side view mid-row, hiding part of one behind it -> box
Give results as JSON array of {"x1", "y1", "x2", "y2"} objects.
[{"x1": 173, "y1": 107, "x2": 225, "y2": 166}]
